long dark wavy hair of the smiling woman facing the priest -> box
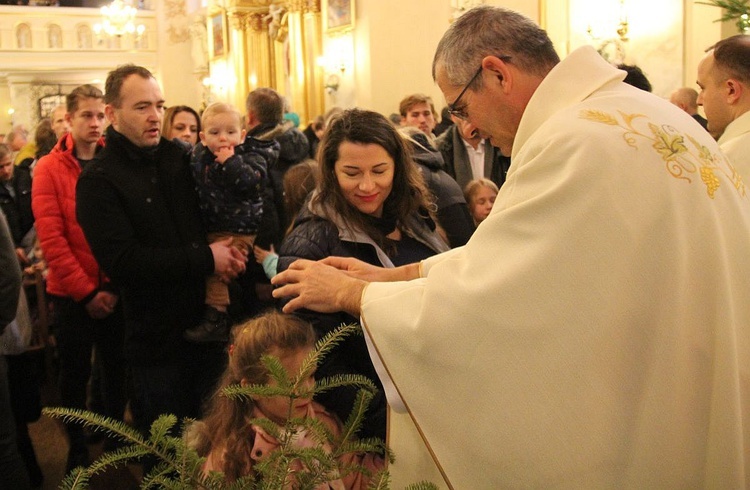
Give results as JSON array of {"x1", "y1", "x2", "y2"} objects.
[{"x1": 313, "y1": 109, "x2": 430, "y2": 250}]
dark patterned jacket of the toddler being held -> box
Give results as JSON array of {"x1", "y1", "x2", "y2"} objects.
[{"x1": 190, "y1": 137, "x2": 279, "y2": 235}]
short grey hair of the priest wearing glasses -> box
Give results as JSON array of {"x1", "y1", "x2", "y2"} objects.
[{"x1": 432, "y1": 5, "x2": 560, "y2": 89}]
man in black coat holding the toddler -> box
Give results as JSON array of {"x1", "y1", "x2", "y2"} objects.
[{"x1": 76, "y1": 65, "x2": 246, "y2": 436}]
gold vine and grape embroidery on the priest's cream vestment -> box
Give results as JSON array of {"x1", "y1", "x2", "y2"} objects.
[{"x1": 580, "y1": 109, "x2": 746, "y2": 199}]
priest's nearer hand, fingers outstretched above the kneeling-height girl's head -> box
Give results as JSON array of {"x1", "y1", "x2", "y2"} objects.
[{"x1": 271, "y1": 260, "x2": 367, "y2": 316}]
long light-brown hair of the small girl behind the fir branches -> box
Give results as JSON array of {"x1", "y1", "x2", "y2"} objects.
[{"x1": 187, "y1": 311, "x2": 315, "y2": 481}]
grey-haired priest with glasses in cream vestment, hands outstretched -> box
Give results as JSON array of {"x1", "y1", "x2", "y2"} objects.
[{"x1": 273, "y1": 7, "x2": 750, "y2": 489}]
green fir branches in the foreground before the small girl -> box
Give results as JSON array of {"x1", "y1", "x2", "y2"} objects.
[{"x1": 43, "y1": 325, "x2": 436, "y2": 490}]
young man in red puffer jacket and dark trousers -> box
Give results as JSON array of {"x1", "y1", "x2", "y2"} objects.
[{"x1": 32, "y1": 85, "x2": 125, "y2": 470}]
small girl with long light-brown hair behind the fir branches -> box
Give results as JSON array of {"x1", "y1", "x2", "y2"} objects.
[{"x1": 188, "y1": 311, "x2": 384, "y2": 489}]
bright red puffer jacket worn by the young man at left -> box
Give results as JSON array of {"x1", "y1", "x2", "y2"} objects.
[{"x1": 31, "y1": 133, "x2": 104, "y2": 302}]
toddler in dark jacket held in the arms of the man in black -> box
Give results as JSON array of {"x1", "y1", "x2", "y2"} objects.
[{"x1": 185, "y1": 102, "x2": 276, "y2": 342}]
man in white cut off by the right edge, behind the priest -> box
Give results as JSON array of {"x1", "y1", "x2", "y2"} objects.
[{"x1": 698, "y1": 34, "x2": 750, "y2": 175}]
